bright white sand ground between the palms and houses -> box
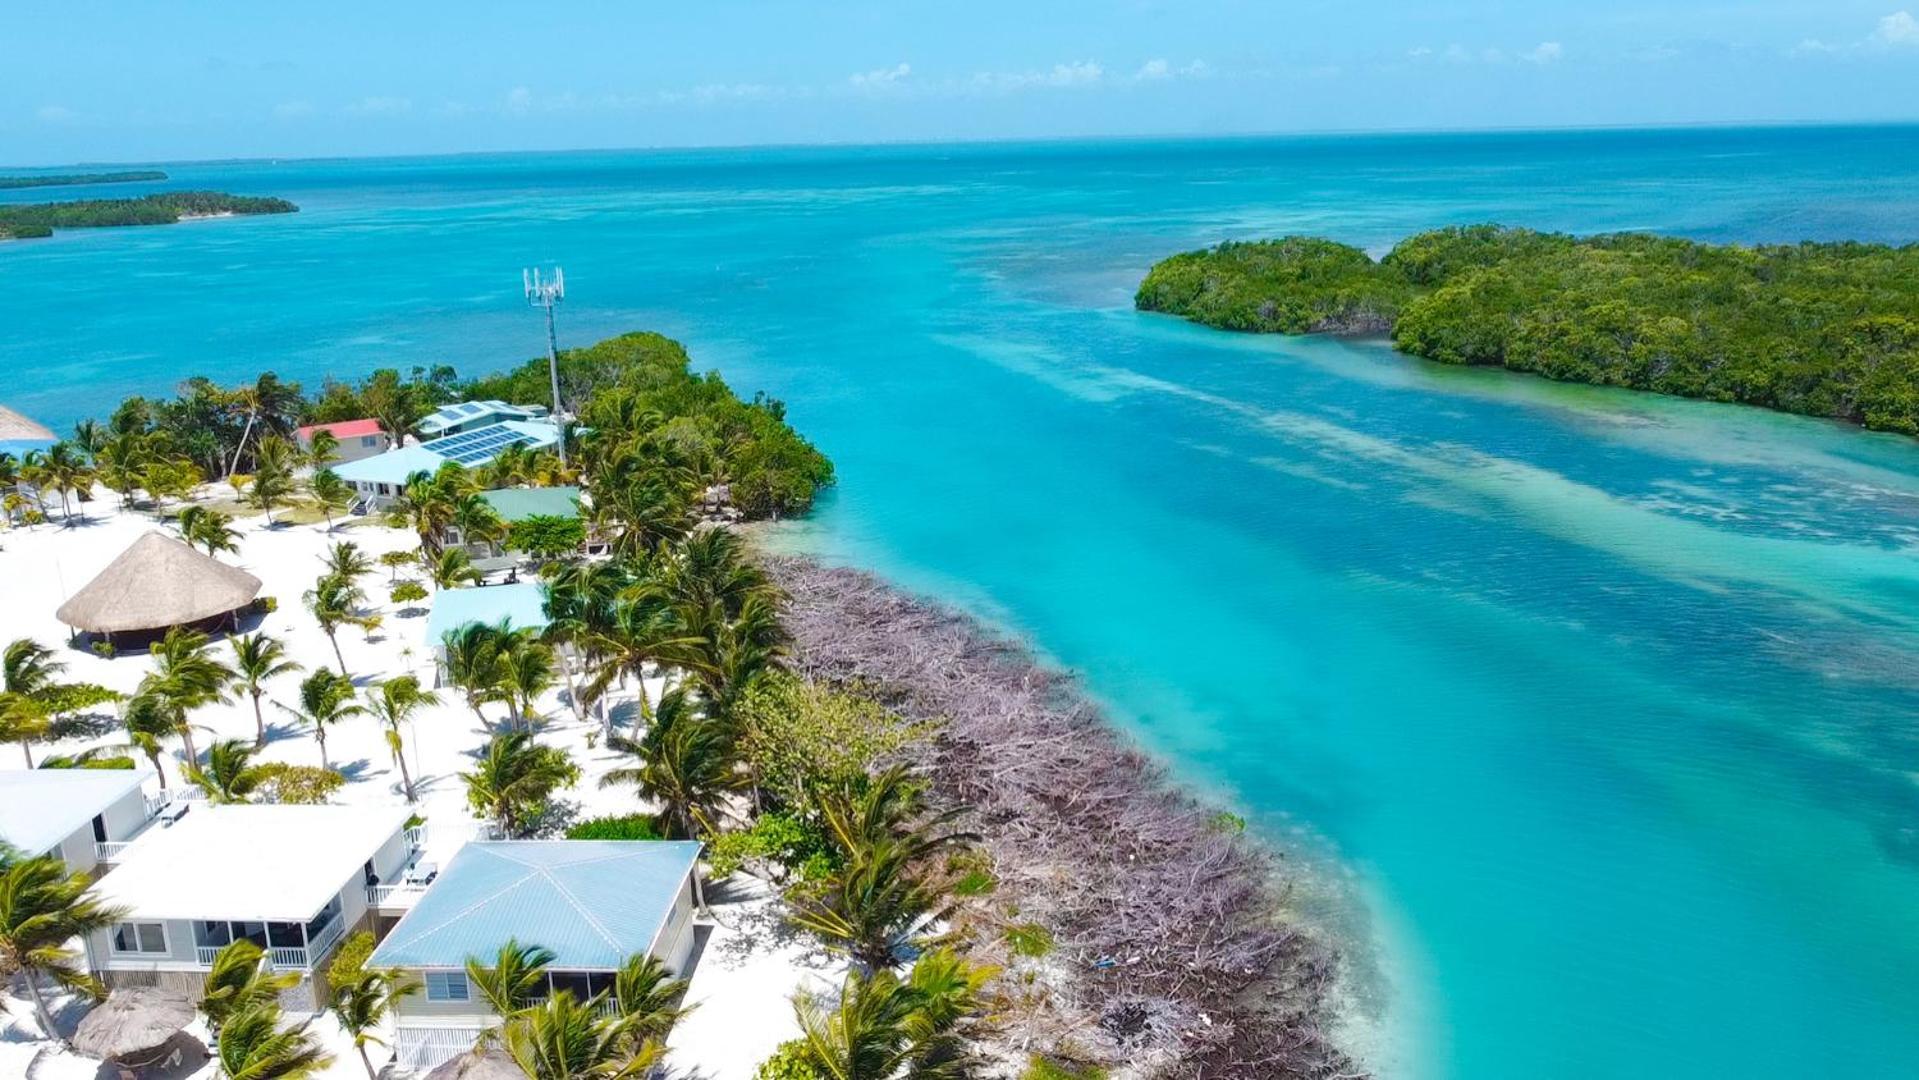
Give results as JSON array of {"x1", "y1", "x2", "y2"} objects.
[{"x1": 0, "y1": 491, "x2": 842, "y2": 1080}]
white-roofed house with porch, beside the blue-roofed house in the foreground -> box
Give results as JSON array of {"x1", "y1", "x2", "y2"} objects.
[{"x1": 86, "y1": 804, "x2": 418, "y2": 1009}]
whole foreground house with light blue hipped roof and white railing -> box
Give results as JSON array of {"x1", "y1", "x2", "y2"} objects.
[{"x1": 368, "y1": 840, "x2": 700, "y2": 1068}]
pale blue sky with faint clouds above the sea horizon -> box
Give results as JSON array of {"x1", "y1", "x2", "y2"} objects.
[{"x1": 11, "y1": 0, "x2": 1919, "y2": 165}]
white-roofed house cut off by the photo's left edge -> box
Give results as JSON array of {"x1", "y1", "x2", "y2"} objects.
[{"x1": 0, "y1": 769, "x2": 163, "y2": 873}]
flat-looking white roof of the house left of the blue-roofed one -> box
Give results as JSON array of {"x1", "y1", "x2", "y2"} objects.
[{"x1": 94, "y1": 804, "x2": 411, "y2": 923}]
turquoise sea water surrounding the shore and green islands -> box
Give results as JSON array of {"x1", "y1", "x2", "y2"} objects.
[{"x1": 0, "y1": 129, "x2": 1919, "y2": 1078}]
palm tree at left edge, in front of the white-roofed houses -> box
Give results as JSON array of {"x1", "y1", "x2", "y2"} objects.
[{"x1": 0, "y1": 856, "x2": 127, "y2": 1044}]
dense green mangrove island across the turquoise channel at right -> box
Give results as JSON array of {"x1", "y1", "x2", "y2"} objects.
[{"x1": 1134, "y1": 224, "x2": 1919, "y2": 435}]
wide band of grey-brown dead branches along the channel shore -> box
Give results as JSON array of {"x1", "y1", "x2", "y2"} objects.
[{"x1": 768, "y1": 556, "x2": 1361, "y2": 1080}]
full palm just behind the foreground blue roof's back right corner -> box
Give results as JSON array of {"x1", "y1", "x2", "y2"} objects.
[{"x1": 601, "y1": 689, "x2": 748, "y2": 840}]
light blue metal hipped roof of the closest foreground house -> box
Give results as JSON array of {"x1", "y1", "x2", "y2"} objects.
[{"x1": 368, "y1": 840, "x2": 700, "y2": 971}]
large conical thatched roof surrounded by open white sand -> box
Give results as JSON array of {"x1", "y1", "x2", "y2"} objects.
[{"x1": 59, "y1": 533, "x2": 259, "y2": 633}]
